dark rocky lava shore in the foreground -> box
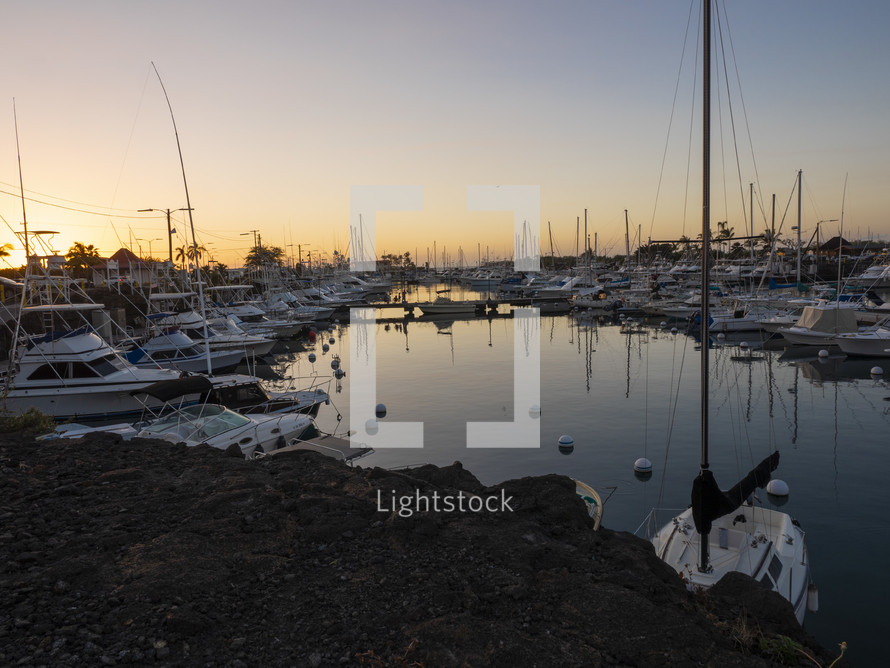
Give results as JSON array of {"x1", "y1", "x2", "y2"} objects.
[{"x1": 0, "y1": 434, "x2": 835, "y2": 668}]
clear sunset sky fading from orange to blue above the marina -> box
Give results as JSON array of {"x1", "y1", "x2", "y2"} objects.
[{"x1": 0, "y1": 0, "x2": 890, "y2": 267}]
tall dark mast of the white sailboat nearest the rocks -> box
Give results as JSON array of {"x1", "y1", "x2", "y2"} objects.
[{"x1": 699, "y1": 0, "x2": 711, "y2": 571}]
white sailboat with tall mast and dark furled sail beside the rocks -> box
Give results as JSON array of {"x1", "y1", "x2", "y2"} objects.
[{"x1": 652, "y1": 0, "x2": 815, "y2": 623}]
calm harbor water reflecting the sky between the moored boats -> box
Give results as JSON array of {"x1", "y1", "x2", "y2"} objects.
[{"x1": 279, "y1": 286, "x2": 890, "y2": 665}]
